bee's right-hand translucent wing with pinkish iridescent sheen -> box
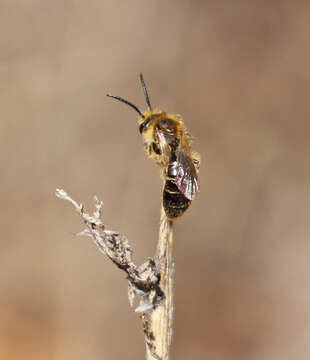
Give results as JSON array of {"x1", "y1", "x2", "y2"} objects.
[{"x1": 176, "y1": 143, "x2": 199, "y2": 200}]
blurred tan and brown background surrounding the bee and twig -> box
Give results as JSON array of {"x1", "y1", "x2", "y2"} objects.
[{"x1": 0, "y1": 0, "x2": 310, "y2": 360}]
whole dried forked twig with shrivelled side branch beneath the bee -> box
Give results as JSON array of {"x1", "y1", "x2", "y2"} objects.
[{"x1": 56, "y1": 189, "x2": 173, "y2": 360}]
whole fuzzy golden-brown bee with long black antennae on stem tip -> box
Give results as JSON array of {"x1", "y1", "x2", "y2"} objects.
[{"x1": 107, "y1": 74, "x2": 200, "y2": 220}]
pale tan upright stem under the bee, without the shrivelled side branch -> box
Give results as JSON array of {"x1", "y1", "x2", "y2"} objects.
[{"x1": 142, "y1": 209, "x2": 174, "y2": 360}]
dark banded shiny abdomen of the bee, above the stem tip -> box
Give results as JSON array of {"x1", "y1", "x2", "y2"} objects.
[{"x1": 163, "y1": 180, "x2": 191, "y2": 219}]
